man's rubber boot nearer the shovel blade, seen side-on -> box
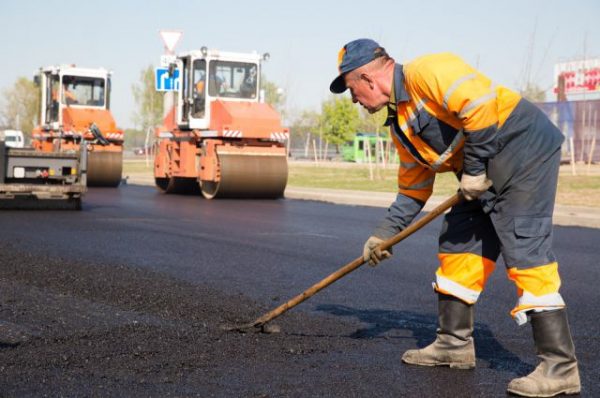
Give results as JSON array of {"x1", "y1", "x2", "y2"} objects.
[{"x1": 402, "y1": 293, "x2": 475, "y2": 369}]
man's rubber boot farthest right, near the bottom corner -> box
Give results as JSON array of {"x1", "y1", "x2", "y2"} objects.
[{"x1": 508, "y1": 308, "x2": 581, "y2": 397}]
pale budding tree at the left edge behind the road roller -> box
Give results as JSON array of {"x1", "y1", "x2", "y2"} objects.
[{"x1": 1, "y1": 77, "x2": 40, "y2": 136}]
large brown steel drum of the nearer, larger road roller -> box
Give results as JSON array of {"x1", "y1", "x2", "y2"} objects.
[{"x1": 200, "y1": 153, "x2": 288, "y2": 199}]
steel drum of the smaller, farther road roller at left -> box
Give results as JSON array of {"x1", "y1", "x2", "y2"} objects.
[{"x1": 87, "y1": 151, "x2": 123, "y2": 187}]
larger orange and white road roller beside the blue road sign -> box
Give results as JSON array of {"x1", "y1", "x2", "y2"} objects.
[{"x1": 154, "y1": 47, "x2": 289, "y2": 199}]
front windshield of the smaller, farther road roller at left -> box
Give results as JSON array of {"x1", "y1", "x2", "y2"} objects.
[{"x1": 61, "y1": 76, "x2": 105, "y2": 107}]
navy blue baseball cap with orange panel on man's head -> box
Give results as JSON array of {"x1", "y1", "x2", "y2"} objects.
[{"x1": 329, "y1": 39, "x2": 386, "y2": 94}]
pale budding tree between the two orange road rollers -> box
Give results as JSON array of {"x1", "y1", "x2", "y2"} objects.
[{"x1": 131, "y1": 65, "x2": 163, "y2": 131}]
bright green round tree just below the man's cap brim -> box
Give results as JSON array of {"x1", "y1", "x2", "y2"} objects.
[{"x1": 321, "y1": 96, "x2": 360, "y2": 150}]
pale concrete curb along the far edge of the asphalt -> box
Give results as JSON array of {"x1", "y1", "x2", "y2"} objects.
[{"x1": 125, "y1": 176, "x2": 600, "y2": 228}]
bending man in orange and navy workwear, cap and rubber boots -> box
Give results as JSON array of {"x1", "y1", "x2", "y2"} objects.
[{"x1": 330, "y1": 39, "x2": 580, "y2": 397}]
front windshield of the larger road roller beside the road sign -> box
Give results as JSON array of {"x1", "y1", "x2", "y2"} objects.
[{"x1": 208, "y1": 61, "x2": 258, "y2": 99}]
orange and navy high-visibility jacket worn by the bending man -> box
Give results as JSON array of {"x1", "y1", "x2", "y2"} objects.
[{"x1": 374, "y1": 53, "x2": 564, "y2": 238}]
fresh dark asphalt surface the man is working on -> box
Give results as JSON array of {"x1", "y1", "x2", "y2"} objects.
[{"x1": 0, "y1": 185, "x2": 600, "y2": 397}]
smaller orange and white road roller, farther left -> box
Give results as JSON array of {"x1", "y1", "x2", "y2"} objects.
[{"x1": 31, "y1": 65, "x2": 123, "y2": 187}]
